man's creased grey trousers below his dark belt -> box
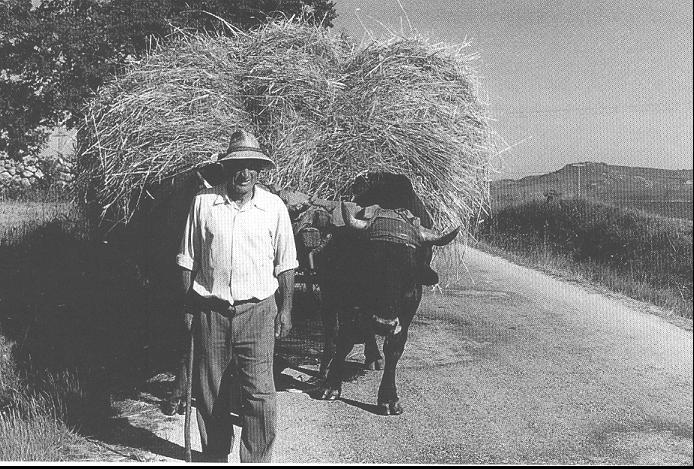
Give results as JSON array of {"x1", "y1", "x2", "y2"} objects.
[{"x1": 193, "y1": 296, "x2": 277, "y2": 463}]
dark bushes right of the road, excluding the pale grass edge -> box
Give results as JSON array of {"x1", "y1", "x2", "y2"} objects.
[{"x1": 479, "y1": 199, "x2": 692, "y2": 312}]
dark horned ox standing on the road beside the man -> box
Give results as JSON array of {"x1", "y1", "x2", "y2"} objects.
[{"x1": 317, "y1": 176, "x2": 460, "y2": 415}]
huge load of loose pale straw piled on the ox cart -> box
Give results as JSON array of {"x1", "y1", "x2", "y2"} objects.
[{"x1": 79, "y1": 21, "x2": 495, "y2": 232}]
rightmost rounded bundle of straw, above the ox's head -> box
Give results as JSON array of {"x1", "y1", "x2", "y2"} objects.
[{"x1": 326, "y1": 38, "x2": 493, "y2": 223}]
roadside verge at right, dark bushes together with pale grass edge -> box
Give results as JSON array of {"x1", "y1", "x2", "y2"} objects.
[{"x1": 477, "y1": 200, "x2": 692, "y2": 318}]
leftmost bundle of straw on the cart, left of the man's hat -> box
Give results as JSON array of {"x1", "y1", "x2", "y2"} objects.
[{"x1": 77, "y1": 36, "x2": 248, "y2": 221}]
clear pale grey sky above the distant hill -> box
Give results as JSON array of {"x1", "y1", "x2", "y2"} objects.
[{"x1": 334, "y1": 0, "x2": 692, "y2": 179}]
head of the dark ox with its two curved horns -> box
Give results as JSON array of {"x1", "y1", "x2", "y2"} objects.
[{"x1": 341, "y1": 203, "x2": 460, "y2": 336}]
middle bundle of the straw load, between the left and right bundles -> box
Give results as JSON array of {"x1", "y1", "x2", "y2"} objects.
[{"x1": 241, "y1": 22, "x2": 346, "y2": 192}]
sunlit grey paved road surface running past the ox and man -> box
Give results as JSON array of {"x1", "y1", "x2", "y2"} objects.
[{"x1": 150, "y1": 249, "x2": 692, "y2": 465}]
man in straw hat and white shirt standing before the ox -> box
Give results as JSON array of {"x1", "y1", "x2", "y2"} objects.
[{"x1": 176, "y1": 130, "x2": 298, "y2": 463}]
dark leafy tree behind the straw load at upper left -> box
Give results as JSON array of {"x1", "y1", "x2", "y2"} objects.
[{"x1": 0, "y1": 0, "x2": 337, "y2": 158}]
